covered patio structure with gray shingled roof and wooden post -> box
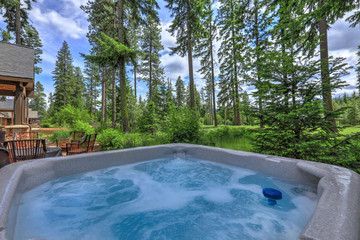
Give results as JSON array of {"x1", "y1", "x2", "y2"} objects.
[{"x1": 0, "y1": 42, "x2": 34, "y2": 125}]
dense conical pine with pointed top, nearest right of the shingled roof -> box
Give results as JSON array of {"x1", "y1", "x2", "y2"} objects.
[{"x1": 52, "y1": 41, "x2": 74, "y2": 112}]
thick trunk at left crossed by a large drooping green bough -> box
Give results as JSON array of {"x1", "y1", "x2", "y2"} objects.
[{"x1": 117, "y1": 0, "x2": 130, "y2": 132}]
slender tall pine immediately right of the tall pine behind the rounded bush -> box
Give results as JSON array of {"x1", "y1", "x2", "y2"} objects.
[{"x1": 194, "y1": 0, "x2": 217, "y2": 127}]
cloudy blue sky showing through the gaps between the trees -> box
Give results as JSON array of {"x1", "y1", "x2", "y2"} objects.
[{"x1": 0, "y1": 0, "x2": 360, "y2": 102}]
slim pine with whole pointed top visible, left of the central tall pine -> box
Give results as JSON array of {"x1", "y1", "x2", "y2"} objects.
[{"x1": 138, "y1": 13, "x2": 164, "y2": 102}]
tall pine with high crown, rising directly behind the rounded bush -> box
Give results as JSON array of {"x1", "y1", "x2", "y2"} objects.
[{"x1": 166, "y1": 0, "x2": 202, "y2": 109}]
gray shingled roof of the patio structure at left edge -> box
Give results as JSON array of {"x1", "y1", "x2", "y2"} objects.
[{"x1": 0, "y1": 42, "x2": 34, "y2": 79}]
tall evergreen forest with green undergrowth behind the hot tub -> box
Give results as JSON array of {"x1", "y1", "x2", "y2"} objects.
[{"x1": 0, "y1": 0, "x2": 360, "y2": 172}]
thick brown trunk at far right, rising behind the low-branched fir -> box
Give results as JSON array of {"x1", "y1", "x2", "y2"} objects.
[{"x1": 319, "y1": 0, "x2": 337, "y2": 132}]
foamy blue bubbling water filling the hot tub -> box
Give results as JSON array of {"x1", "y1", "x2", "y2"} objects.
[{"x1": 14, "y1": 158, "x2": 317, "y2": 240}]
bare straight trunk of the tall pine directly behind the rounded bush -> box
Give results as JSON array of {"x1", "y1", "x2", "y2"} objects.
[{"x1": 186, "y1": 0, "x2": 196, "y2": 110}]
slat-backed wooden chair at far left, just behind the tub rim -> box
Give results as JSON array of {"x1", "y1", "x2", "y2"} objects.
[{"x1": 4, "y1": 139, "x2": 46, "y2": 163}]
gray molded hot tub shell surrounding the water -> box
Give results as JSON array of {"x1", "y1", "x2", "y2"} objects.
[{"x1": 0, "y1": 144, "x2": 360, "y2": 240}]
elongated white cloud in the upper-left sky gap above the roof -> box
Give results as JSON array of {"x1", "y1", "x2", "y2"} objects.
[{"x1": 30, "y1": 7, "x2": 87, "y2": 39}]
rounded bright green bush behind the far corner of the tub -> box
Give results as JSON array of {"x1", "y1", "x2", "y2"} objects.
[{"x1": 165, "y1": 106, "x2": 200, "y2": 143}]
